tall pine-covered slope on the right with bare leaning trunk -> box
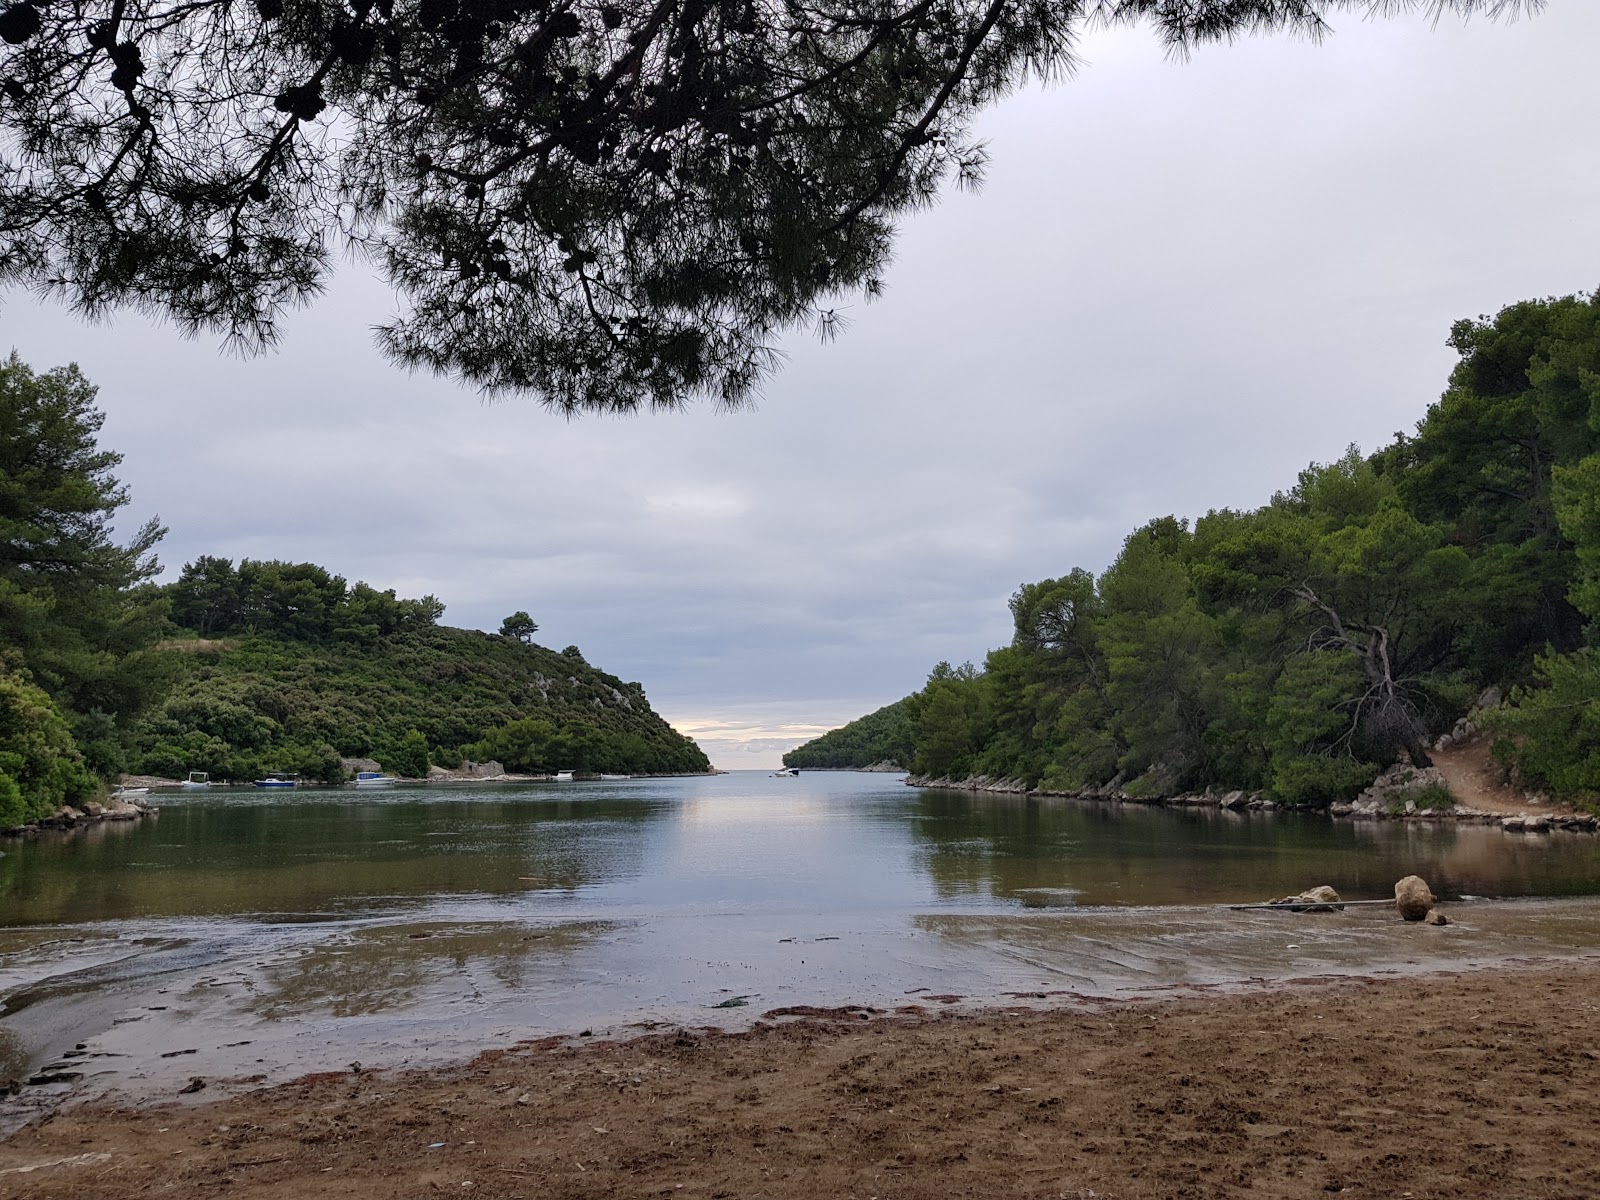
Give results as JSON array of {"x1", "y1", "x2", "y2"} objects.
[{"x1": 819, "y1": 296, "x2": 1600, "y2": 803}]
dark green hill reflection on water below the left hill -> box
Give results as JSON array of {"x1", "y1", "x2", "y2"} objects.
[{"x1": 0, "y1": 794, "x2": 672, "y2": 926}]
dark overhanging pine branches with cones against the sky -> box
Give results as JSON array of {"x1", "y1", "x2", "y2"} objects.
[{"x1": 0, "y1": 0, "x2": 1542, "y2": 411}]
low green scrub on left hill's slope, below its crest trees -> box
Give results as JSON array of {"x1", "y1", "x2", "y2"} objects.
[{"x1": 130, "y1": 611, "x2": 709, "y2": 781}]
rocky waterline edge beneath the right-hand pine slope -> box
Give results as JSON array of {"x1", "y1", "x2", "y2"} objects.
[{"x1": 906, "y1": 763, "x2": 1600, "y2": 834}]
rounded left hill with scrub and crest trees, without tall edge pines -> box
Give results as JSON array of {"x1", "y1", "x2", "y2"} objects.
[{"x1": 131, "y1": 557, "x2": 709, "y2": 781}]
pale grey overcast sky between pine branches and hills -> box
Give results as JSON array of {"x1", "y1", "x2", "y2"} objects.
[{"x1": 0, "y1": 0, "x2": 1600, "y2": 768}]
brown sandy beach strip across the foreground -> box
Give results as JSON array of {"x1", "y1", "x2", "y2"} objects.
[{"x1": 0, "y1": 955, "x2": 1600, "y2": 1200}]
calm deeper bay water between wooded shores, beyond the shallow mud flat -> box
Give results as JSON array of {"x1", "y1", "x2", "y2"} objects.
[{"x1": 0, "y1": 773, "x2": 1600, "y2": 926}]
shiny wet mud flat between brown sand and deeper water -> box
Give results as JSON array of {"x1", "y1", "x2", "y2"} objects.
[{"x1": 9, "y1": 899, "x2": 1600, "y2": 1139}]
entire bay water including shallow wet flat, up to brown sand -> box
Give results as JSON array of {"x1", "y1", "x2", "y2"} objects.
[{"x1": 0, "y1": 773, "x2": 1600, "y2": 1113}]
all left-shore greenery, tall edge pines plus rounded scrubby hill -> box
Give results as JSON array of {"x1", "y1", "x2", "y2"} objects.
[{"x1": 0, "y1": 354, "x2": 709, "y2": 829}]
